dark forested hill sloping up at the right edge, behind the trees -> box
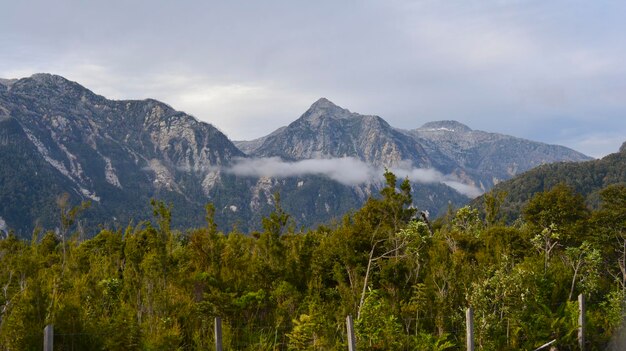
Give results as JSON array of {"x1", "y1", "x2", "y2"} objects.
[{"x1": 472, "y1": 142, "x2": 626, "y2": 219}]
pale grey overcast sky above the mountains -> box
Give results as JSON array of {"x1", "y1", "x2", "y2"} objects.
[{"x1": 0, "y1": 0, "x2": 626, "y2": 157}]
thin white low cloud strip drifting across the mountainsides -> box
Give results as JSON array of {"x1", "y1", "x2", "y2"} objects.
[{"x1": 225, "y1": 157, "x2": 482, "y2": 198}]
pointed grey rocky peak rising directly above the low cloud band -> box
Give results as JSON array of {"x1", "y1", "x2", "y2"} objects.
[{"x1": 235, "y1": 98, "x2": 432, "y2": 167}]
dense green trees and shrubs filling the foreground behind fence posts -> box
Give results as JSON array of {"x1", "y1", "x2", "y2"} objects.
[{"x1": 0, "y1": 173, "x2": 626, "y2": 350}]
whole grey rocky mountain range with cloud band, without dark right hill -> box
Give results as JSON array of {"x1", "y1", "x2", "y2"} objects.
[{"x1": 0, "y1": 74, "x2": 590, "y2": 239}]
